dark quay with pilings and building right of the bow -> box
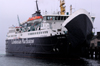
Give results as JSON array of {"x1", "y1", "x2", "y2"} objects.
[{"x1": 82, "y1": 32, "x2": 100, "y2": 60}]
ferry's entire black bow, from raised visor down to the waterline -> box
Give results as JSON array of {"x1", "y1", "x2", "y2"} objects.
[{"x1": 65, "y1": 14, "x2": 93, "y2": 56}]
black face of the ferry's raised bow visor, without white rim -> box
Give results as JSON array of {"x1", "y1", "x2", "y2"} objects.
[{"x1": 65, "y1": 14, "x2": 93, "y2": 48}]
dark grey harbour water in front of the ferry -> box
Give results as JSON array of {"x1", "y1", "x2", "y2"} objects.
[{"x1": 0, "y1": 53, "x2": 100, "y2": 66}]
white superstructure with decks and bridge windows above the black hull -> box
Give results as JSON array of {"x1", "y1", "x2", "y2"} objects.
[{"x1": 7, "y1": 15, "x2": 69, "y2": 39}]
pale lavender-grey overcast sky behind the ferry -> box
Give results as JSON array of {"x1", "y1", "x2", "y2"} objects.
[{"x1": 0, "y1": 0, "x2": 100, "y2": 51}]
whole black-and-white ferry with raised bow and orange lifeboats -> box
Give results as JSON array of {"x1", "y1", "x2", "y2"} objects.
[{"x1": 6, "y1": 0, "x2": 95, "y2": 57}]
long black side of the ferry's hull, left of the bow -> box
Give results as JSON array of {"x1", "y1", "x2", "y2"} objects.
[{"x1": 6, "y1": 35, "x2": 67, "y2": 57}]
